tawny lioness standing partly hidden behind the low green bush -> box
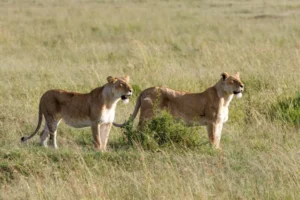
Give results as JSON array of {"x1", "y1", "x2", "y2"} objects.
[{"x1": 113, "y1": 72, "x2": 244, "y2": 148}]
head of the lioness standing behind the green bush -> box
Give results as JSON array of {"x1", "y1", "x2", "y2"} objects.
[{"x1": 221, "y1": 72, "x2": 244, "y2": 98}]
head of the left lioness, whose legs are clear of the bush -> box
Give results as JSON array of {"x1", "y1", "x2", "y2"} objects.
[{"x1": 107, "y1": 75, "x2": 133, "y2": 103}]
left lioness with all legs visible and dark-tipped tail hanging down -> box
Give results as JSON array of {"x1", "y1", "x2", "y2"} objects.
[{"x1": 21, "y1": 76, "x2": 132, "y2": 151}]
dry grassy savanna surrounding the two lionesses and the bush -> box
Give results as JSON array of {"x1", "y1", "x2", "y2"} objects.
[{"x1": 0, "y1": 0, "x2": 300, "y2": 199}]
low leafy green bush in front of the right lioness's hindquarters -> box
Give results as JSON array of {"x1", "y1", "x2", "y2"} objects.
[{"x1": 123, "y1": 111, "x2": 203, "y2": 151}]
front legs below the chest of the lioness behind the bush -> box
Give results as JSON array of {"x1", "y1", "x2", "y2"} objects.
[{"x1": 206, "y1": 123, "x2": 223, "y2": 149}]
